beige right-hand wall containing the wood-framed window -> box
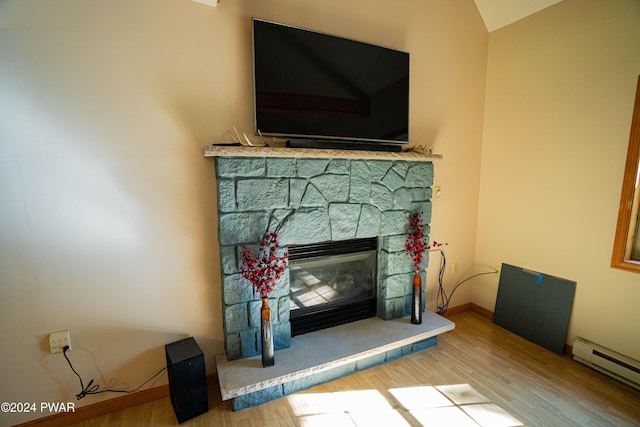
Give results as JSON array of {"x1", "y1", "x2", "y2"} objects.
[{"x1": 473, "y1": 0, "x2": 640, "y2": 360}]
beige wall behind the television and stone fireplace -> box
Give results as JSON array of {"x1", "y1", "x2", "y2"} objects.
[{"x1": 0, "y1": 0, "x2": 488, "y2": 425}]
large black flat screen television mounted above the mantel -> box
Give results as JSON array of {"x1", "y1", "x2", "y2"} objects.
[{"x1": 253, "y1": 18, "x2": 409, "y2": 151}]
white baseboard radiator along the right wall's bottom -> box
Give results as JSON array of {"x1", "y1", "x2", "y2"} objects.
[{"x1": 573, "y1": 337, "x2": 640, "y2": 390}]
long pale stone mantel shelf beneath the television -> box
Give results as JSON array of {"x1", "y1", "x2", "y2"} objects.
[{"x1": 203, "y1": 145, "x2": 443, "y2": 162}]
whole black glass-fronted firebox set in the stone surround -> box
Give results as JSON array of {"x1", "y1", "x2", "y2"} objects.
[{"x1": 289, "y1": 237, "x2": 378, "y2": 336}]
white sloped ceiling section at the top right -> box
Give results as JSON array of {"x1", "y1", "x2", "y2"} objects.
[{"x1": 475, "y1": 0, "x2": 562, "y2": 32}]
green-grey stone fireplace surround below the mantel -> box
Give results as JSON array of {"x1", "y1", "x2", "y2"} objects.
[{"x1": 216, "y1": 149, "x2": 433, "y2": 360}]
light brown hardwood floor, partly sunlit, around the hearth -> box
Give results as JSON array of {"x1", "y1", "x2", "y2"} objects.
[{"x1": 65, "y1": 312, "x2": 640, "y2": 427}]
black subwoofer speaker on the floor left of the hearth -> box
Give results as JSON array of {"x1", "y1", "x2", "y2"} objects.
[{"x1": 164, "y1": 338, "x2": 209, "y2": 423}]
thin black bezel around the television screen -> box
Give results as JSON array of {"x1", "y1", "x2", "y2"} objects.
[{"x1": 251, "y1": 17, "x2": 411, "y2": 151}]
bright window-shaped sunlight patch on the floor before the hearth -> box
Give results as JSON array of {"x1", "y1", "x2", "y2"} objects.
[{"x1": 287, "y1": 384, "x2": 523, "y2": 427}]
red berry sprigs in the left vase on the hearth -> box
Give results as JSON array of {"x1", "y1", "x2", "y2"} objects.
[{"x1": 240, "y1": 232, "x2": 289, "y2": 298}]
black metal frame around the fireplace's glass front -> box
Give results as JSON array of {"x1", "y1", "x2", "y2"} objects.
[{"x1": 288, "y1": 237, "x2": 378, "y2": 337}]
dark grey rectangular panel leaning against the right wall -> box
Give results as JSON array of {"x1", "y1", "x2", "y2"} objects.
[{"x1": 493, "y1": 264, "x2": 576, "y2": 354}]
